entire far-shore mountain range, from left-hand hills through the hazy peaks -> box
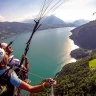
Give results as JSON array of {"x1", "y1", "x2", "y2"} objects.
[{"x1": 0, "y1": 15, "x2": 90, "y2": 39}]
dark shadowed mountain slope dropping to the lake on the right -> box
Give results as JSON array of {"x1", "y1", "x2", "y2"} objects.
[{"x1": 70, "y1": 20, "x2": 96, "y2": 49}]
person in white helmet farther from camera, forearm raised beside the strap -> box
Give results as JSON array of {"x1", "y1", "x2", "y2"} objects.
[{"x1": 0, "y1": 43, "x2": 31, "y2": 83}]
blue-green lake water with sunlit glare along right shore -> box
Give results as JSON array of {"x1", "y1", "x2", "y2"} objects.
[{"x1": 0, "y1": 27, "x2": 77, "y2": 84}]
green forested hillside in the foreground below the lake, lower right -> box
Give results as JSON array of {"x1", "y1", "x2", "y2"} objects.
[{"x1": 55, "y1": 54, "x2": 96, "y2": 96}]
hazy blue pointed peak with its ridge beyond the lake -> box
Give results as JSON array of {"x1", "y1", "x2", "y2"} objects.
[{"x1": 22, "y1": 15, "x2": 75, "y2": 27}]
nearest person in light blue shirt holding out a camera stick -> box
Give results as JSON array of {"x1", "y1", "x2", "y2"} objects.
[{"x1": 0, "y1": 48, "x2": 56, "y2": 96}]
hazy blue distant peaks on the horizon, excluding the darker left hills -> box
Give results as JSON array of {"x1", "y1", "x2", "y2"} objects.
[{"x1": 22, "y1": 15, "x2": 89, "y2": 27}]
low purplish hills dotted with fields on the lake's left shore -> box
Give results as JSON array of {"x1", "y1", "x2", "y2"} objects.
[{"x1": 0, "y1": 22, "x2": 34, "y2": 40}]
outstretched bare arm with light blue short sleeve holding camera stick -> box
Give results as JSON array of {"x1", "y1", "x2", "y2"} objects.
[{"x1": 10, "y1": 65, "x2": 56, "y2": 93}]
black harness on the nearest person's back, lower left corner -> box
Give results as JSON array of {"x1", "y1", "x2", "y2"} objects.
[{"x1": 0, "y1": 68, "x2": 14, "y2": 96}]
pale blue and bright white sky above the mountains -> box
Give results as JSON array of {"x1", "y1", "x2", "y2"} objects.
[{"x1": 0, "y1": 0, "x2": 96, "y2": 22}]
